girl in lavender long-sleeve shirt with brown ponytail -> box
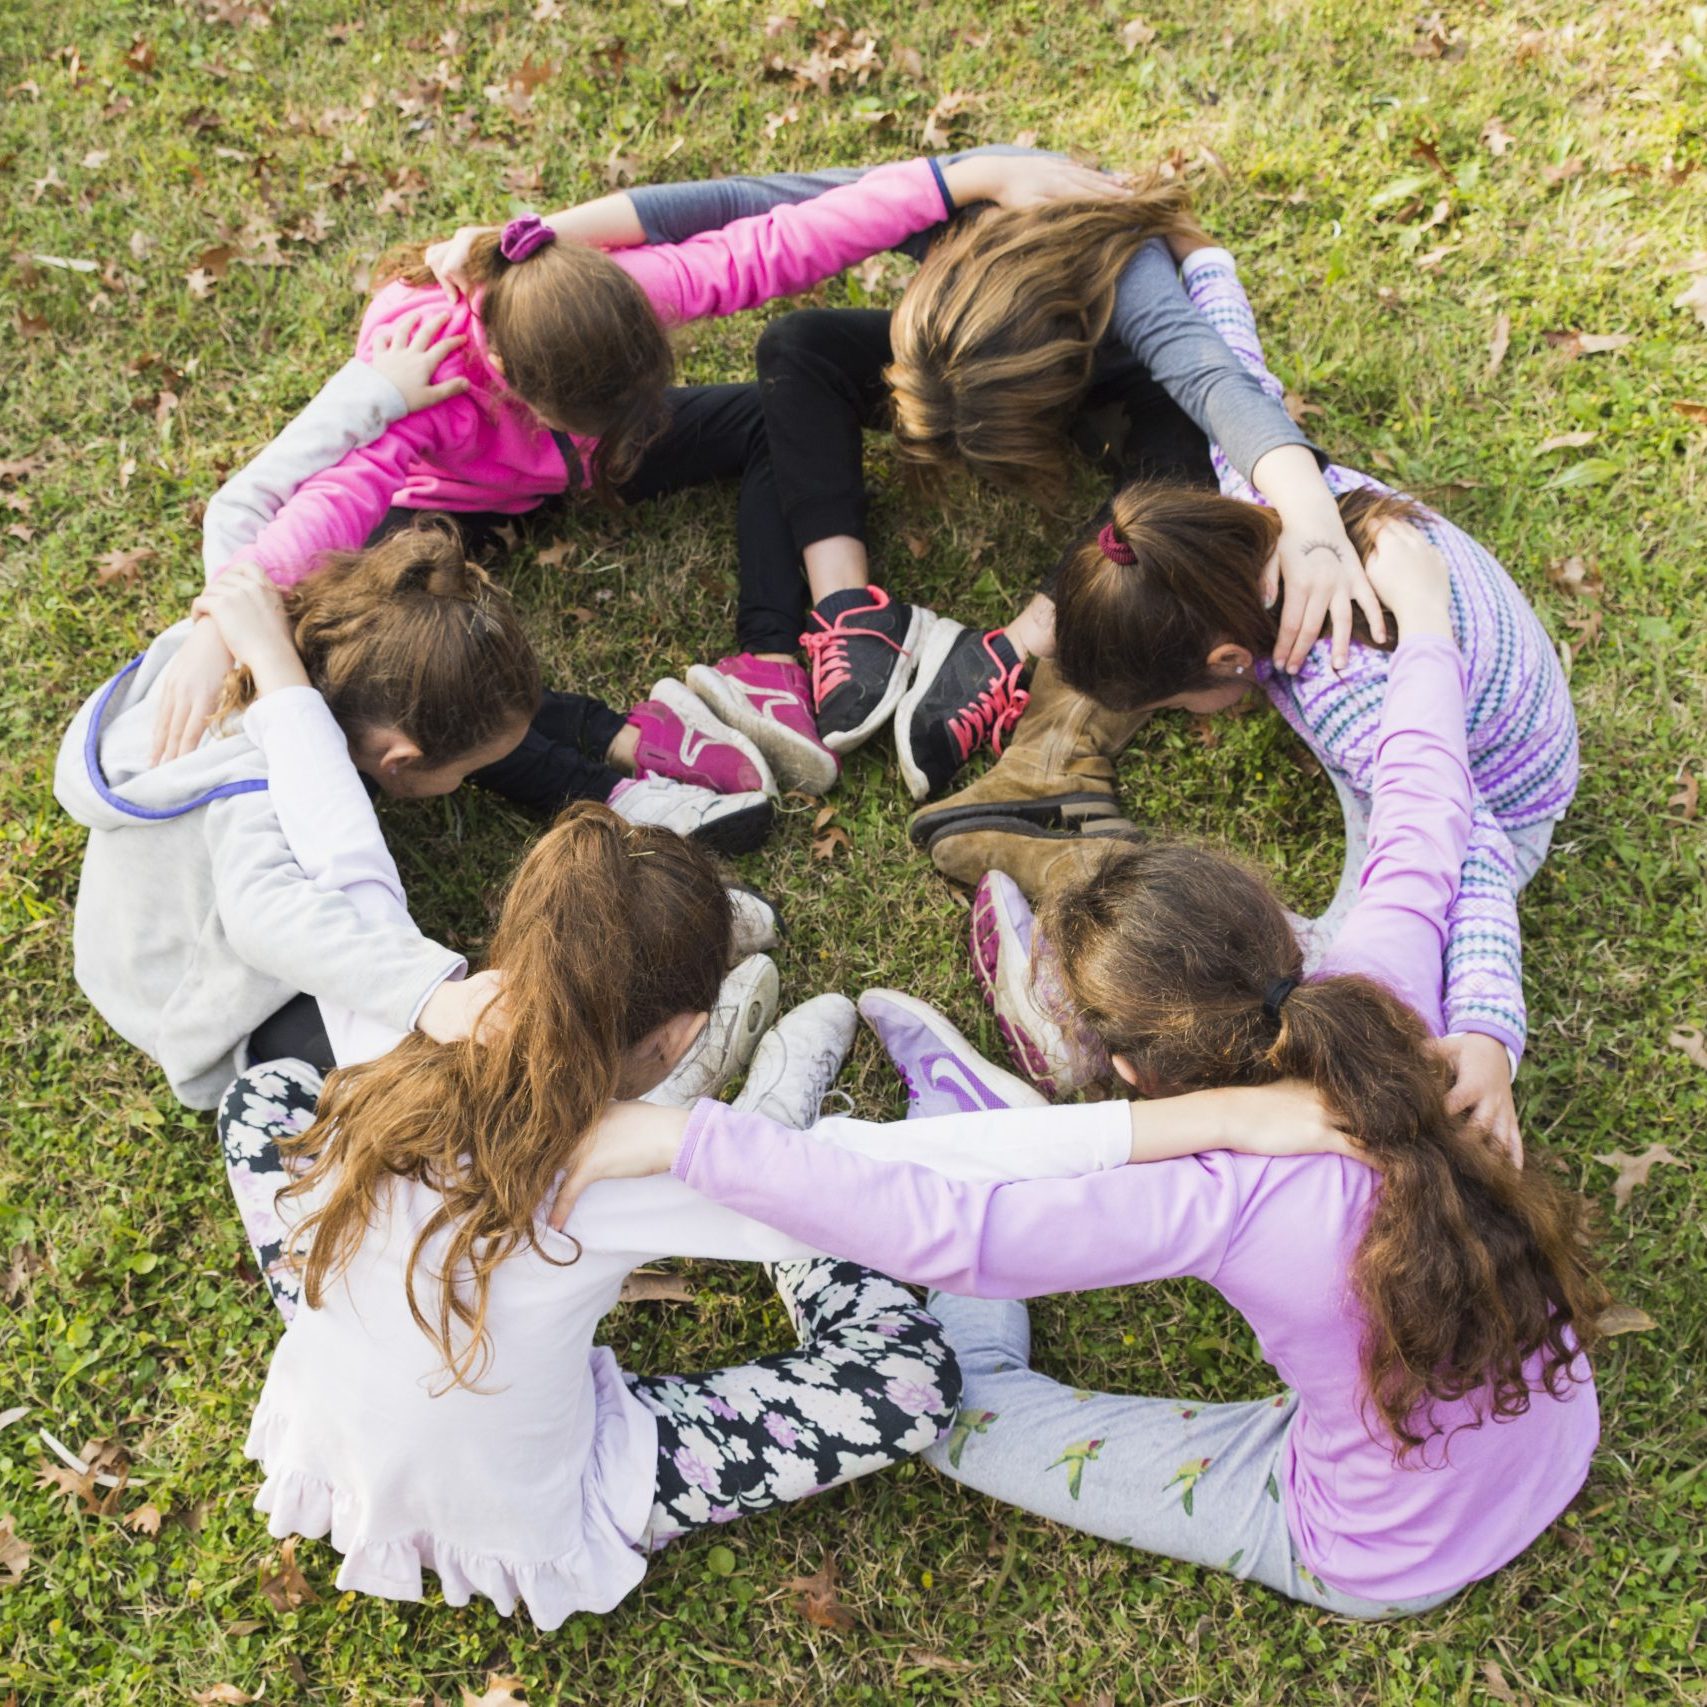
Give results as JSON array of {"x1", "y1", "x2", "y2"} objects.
[{"x1": 565, "y1": 527, "x2": 1605, "y2": 1617}]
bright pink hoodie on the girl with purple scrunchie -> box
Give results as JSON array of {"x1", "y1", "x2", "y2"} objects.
[{"x1": 220, "y1": 160, "x2": 951, "y2": 586}]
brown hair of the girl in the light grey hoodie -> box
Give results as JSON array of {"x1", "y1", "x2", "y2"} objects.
[{"x1": 215, "y1": 521, "x2": 539, "y2": 770}]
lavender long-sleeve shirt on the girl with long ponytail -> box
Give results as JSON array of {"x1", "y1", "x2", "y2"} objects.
[{"x1": 676, "y1": 637, "x2": 1599, "y2": 1599}]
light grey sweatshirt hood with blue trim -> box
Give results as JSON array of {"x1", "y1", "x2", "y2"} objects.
[{"x1": 53, "y1": 621, "x2": 266, "y2": 830}]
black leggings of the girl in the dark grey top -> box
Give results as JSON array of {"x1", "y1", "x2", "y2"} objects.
[{"x1": 758, "y1": 309, "x2": 1215, "y2": 573}]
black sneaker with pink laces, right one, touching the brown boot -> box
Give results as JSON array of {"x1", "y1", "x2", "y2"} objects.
[{"x1": 894, "y1": 618, "x2": 1029, "y2": 801}]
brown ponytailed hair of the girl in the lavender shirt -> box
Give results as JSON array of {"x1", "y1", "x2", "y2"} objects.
[{"x1": 1038, "y1": 842, "x2": 1606, "y2": 1459}]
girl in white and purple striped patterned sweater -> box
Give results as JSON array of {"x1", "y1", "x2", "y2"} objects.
[{"x1": 1031, "y1": 233, "x2": 1577, "y2": 1145}]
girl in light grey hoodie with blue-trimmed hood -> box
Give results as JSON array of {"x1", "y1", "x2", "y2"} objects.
[{"x1": 55, "y1": 323, "x2": 777, "y2": 1108}]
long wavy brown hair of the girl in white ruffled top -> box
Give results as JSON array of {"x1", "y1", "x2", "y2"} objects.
[{"x1": 282, "y1": 802, "x2": 732, "y2": 1388}]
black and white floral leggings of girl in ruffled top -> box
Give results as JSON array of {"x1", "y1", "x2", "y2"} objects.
[{"x1": 218, "y1": 1062, "x2": 961, "y2": 1548}]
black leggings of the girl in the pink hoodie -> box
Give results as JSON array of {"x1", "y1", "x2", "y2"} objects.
[{"x1": 367, "y1": 384, "x2": 806, "y2": 813}]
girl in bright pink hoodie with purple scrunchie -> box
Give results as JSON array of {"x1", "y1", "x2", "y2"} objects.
[{"x1": 150, "y1": 151, "x2": 1091, "y2": 801}]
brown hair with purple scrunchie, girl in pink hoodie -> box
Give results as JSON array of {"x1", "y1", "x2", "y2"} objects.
[{"x1": 374, "y1": 230, "x2": 676, "y2": 502}]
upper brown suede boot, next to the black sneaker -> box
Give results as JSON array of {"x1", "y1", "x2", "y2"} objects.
[{"x1": 906, "y1": 657, "x2": 1149, "y2": 853}]
